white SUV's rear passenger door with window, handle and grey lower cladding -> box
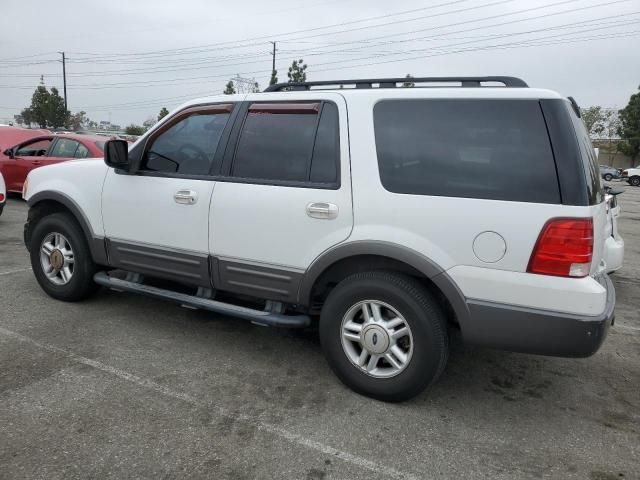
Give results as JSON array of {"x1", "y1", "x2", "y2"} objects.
[{"x1": 209, "y1": 92, "x2": 353, "y2": 301}]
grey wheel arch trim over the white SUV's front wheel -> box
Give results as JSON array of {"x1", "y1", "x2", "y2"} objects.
[{"x1": 24, "y1": 191, "x2": 108, "y2": 265}]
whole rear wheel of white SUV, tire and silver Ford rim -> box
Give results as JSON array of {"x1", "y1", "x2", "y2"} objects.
[{"x1": 320, "y1": 272, "x2": 448, "y2": 402}]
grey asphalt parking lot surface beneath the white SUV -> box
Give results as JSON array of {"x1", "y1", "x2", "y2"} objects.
[{"x1": 0, "y1": 188, "x2": 640, "y2": 480}]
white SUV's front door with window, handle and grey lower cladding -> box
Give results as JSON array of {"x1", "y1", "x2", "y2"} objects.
[{"x1": 102, "y1": 104, "x2": 233, "y2": 286}]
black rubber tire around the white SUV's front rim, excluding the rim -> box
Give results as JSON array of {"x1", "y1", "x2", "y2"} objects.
[{"x1": 29, "y1": 213, "x2": 98, "y2": 302}]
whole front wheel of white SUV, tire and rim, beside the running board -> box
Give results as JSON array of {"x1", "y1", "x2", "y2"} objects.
[{"x1": 29, "y1": 213, "x2": 97, "y2": 302}]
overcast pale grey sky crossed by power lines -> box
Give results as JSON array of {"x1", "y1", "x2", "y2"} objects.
[{"x1": 0, "y1": 0, "x2": 640, "y2": 126}]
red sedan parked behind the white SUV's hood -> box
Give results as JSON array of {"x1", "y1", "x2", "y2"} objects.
[{"x1": 0, "y1": 134, "x2": 109, "y2": 192}]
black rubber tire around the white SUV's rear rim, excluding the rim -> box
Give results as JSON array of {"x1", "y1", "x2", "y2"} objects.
[{"x1": 320, "y1": 272, "x2": 449, "y2": 402}]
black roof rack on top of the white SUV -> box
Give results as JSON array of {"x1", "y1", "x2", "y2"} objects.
[{"x1": 264, "y1": 76, "x2": 529, "y2": 92}]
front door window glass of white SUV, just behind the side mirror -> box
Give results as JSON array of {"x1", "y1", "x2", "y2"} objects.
[{"x1": 142, "y1": 113, "x2": 229, "y2": 175}]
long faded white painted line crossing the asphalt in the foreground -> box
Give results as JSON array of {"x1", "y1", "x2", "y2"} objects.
[{"x1": 0, "y1": 327, "x2": 418, "y2": 480}]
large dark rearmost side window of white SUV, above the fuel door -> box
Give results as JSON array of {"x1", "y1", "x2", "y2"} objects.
[{"x1": 374, "y1": 99, "x2": 560, "y2": 203}]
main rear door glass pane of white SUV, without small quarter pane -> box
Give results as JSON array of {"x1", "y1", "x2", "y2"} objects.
[{"x1": 232, "y1": 111, "x2": 318, "y2": 182}]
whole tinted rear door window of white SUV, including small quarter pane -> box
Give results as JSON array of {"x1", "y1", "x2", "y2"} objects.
[{"x1": 231, "y1": 102, "x2": 339, "y2": 185}]
